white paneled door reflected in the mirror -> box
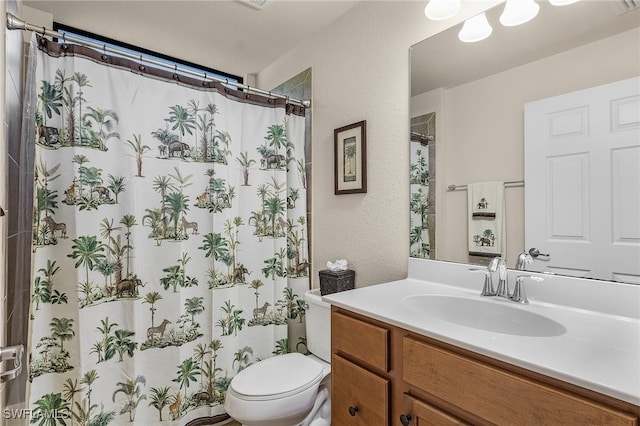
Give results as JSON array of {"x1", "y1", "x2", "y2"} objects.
[{"x1": 525, "y1": 78, "x2": 640, "y2": 284}]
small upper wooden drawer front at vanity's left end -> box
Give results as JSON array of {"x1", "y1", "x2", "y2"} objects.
[{"x1": 331, "y1": 311, "x2": 390, "y2": 372}]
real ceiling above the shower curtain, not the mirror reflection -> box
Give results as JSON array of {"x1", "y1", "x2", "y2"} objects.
[{"x1": 23, "y1": 0, "x2": 360, "y2": 77}]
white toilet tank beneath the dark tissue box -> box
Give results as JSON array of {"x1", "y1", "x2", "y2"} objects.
[{"x1": 304, "y1": 288, "x2": 331, "y2": 363}]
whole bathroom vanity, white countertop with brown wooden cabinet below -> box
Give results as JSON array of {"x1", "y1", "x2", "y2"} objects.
[{"x1": 324, "y1": 259, "x2": 640, "y2": 426}]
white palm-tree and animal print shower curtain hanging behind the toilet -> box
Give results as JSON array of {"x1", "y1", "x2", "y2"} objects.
[{"x1": 28, "y1": 37, "x2": 309, "y2": 426}]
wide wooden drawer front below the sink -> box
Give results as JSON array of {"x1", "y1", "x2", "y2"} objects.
[{"x1": 403, "y1": 337, "x2": 638, "y2": 426}]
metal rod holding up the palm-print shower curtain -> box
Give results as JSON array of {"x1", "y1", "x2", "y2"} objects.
[{"x1": 7, "y1": 13, "x2": 311, "y2": 108}]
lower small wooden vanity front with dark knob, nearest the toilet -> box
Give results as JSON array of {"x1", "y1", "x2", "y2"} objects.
[{"x1": 331, "y1": 355, "x2": 390, "y2": 426}]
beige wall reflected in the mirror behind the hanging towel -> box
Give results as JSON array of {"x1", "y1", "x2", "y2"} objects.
[{"x1": 411, "y1": 29, "x2": 640, "y2": 266}]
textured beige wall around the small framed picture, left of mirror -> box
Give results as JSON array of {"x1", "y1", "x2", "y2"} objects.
[{"x1": 258, "y1": 1, "x2": 498, "y2": 287}]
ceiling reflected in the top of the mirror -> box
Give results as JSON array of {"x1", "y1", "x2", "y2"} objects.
[{"x1": 411, "y1": 0, "x2": 640, "y2": 96}]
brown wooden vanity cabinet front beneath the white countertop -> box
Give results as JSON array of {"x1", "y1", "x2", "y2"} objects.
[{"x1": 331, "y1": 307, "x2": 640, "y2": 426}]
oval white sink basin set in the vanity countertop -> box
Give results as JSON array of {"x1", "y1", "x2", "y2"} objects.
[{"x1": 402, "y1": 294, "x2": 567, "y2": 337}]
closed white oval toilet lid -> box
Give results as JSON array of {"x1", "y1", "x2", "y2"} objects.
[{"x1": 231, "y1": 352, "x2": 324, "y2": 399}]
